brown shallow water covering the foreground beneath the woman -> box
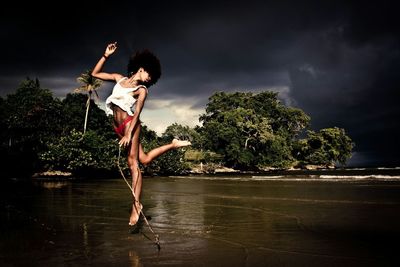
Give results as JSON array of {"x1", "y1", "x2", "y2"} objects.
[{"x1": 0, "y1": 176, "x2": 400, "y2": 267}]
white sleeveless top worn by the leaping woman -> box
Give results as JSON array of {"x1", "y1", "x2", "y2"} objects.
[{"x1": 106, "y1": 77, "x2": 147, "y2": 116}]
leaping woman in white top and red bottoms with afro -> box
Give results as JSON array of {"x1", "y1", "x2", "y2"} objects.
[{"x1": 92, "y1": 42, "x2": 190, "y2": 225}]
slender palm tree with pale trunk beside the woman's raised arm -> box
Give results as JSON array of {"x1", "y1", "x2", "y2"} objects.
[{"x1": 74, "y1": 70, "x2": 103, "y2": 134}]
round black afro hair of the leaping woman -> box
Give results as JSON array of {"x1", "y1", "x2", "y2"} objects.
[{"x1": 128, "y1": 49, "x2": 161, "y2": 87}]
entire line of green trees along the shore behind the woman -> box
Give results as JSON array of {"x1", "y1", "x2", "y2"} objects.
[{"x1": 0, "y1": 77, "x2": 354, "y2": 177}]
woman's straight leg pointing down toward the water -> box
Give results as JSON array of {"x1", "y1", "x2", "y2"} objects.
[{"x1": 128, "y1": 125, "x2": 143, "y2": 225}]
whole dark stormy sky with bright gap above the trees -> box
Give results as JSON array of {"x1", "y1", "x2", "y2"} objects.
[{"x1": 0, "y1": 0, "x2": 400, "y2": 166}]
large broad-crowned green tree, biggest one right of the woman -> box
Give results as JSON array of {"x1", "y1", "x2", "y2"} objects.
[{"x1": 200, "y1": 92, "x2": 310, "y2": 169}]
